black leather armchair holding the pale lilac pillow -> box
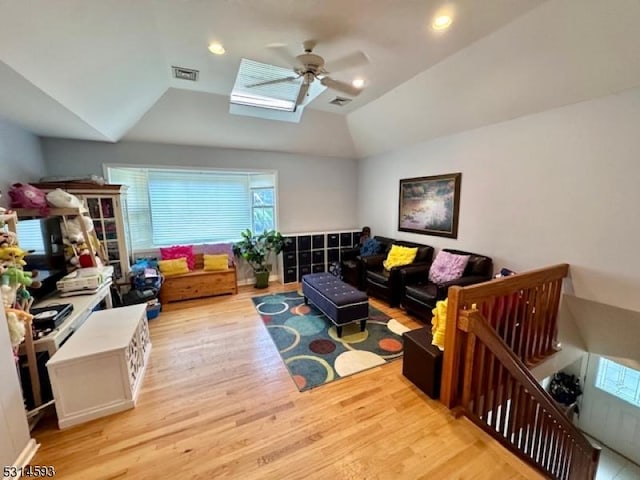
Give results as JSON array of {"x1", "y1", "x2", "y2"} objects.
[{"x1": 401, "y1": 248, "x2": 493, "y2": 320}]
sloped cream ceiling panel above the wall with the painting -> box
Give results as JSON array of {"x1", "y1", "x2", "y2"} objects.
[{"x1": 348, "y1": 0, "x2": 640, "y2": 157}]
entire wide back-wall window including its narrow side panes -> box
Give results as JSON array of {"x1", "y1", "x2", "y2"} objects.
[{"x1": 107, "y1": 167, "x2": 275, "y2": 250}]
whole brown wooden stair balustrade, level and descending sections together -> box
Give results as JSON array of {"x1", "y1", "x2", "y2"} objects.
[{"x1": 440, "y1": 264, "x2": 600, "y2": 480}]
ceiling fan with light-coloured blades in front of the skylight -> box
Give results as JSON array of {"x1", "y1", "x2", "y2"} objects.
[{"x1": 247, "y1": 40, "x2": 369, "y2": 107}]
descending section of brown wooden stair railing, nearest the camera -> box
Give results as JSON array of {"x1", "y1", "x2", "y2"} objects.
[{"x1": 456, "y1": 310, "x2": 600, "y2": 480}]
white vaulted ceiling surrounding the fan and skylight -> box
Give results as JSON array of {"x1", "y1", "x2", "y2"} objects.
[{"x1": 0, "y1": 0, "x2": 544, "y2": 157}]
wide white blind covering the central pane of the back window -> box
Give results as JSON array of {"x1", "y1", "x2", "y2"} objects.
[{"x1": 149, "y1": 170, "x2": 251, "y2": 245}]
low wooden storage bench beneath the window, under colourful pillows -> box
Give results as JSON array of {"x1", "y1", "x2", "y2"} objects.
[{"x1": 160, "y1": 253, "x2": 238, "y2": 303}]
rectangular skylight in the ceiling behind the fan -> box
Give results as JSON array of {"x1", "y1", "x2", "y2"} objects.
[{"x1": 229, "y1": 58, "x2": 326, "y2": 122}]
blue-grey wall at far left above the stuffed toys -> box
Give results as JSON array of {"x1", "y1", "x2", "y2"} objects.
[{"x1": 0, "y1": 117, "x2": 46, "y2": 207}]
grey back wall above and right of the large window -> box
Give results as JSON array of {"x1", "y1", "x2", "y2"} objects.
[{"x1": 42, "y1": 138, "x2": 358, "y2": 233}]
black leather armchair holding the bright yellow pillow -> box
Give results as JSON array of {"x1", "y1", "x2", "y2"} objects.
[{"x1": 362, "y1": 240, "x2": 433, "y2": 307}]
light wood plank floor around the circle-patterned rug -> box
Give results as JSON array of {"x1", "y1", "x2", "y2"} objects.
[{"x1": 32, "y1": 284, "x2": 542, "y2": 480}]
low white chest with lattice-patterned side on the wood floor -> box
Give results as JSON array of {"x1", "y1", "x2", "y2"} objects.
[{"x1": 47, "y1": 304, "x2": 151, "y2": 428}]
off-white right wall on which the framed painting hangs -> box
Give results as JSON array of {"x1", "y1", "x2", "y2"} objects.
[{"x1": 358, "y1": 88, "x2": 640, "y2": 311}]
